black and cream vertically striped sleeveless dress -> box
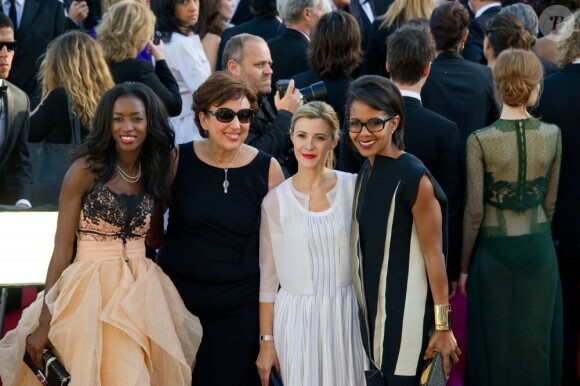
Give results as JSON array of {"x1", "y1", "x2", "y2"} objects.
[{"x1": 352, "y1": 153, "x2": 447, "y2": 386}]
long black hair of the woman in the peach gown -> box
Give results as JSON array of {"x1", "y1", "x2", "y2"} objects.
[{"x1": 73, "y1": 82, "x2": 176, "y2": 207}]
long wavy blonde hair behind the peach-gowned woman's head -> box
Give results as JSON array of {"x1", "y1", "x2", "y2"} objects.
[{"x1": 38, "y1": 31, "x2": 115, "y2": 128}]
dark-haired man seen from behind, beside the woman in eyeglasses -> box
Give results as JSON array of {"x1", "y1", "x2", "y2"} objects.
[{"x1": 387, "y1": 27, "x2": 463, "y2": 288}]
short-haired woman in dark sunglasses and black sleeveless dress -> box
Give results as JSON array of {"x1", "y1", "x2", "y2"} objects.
[{"x1": 152, "y1": 72, "x2": 284, "y2": 386}]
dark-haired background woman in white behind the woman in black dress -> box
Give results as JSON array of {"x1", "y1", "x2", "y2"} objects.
[{"x1": 151, "y1": 0, "x2": 211, "y2": 144}]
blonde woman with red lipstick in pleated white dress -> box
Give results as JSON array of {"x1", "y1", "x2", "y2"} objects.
[{"x1": 256, "y1": 102, "x2": 366, "y2": 386}]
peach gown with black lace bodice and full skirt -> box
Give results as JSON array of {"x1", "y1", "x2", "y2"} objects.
[{"x1": 0, "y1": 182, "x2": 202, "y2": 386}]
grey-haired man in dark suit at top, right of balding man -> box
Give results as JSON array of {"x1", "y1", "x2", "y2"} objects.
[{"x1": 268, "y1": 0, "x2": 324, "y2": 94}]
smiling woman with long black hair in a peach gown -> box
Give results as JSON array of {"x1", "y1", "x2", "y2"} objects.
[{"x1": 0, "y1": 83, "x2": 202, "y2": 386}]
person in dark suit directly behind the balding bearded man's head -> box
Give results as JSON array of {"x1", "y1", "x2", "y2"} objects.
[{"x1": 217, "y1": 0, "x2": 286, "y2": 70}]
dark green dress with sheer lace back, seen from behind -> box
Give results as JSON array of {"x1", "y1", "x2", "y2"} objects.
[{"x1": 461, "y1": 119, "x2": 562, "y2": 386}]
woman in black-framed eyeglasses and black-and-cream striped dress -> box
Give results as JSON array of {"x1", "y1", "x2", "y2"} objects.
[{"x1": 346, "y1": 75, "x2": 460, "y2": 386}]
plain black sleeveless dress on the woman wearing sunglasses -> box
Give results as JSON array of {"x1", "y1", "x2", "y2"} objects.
[{"x1": 158, "y1": 142, "x2": 271, "y2": 386}]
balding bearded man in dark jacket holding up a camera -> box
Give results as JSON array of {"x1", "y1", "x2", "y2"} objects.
[{"x1": 222, "y1": 34, "x2": 302, "y2": 177}]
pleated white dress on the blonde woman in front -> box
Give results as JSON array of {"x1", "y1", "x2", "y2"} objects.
[{"x1": 260, "y1": 171, "x2": 366, "y2": 386}]
